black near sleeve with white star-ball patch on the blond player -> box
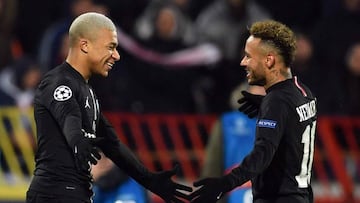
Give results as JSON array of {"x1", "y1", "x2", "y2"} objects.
[{"x1": 39, "y1": 79, "x2": 83, "y2": 147}]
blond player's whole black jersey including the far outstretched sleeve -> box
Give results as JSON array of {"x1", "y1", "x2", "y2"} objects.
[{"x1": 29, "y1": 62, "x2": 151, "y2": 202}]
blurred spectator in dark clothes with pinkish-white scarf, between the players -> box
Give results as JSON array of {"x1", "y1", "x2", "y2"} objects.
[{"x1": 94, "y1": 4, "x2": 216, "y2": 113}]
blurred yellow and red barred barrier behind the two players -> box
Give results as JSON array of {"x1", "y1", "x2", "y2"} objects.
[{"x1": 0, "y1": 107, "x2": 360, "y2": 203}]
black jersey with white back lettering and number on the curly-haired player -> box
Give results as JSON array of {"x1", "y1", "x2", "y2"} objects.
[{"x1": 232, "y1": 77, "x2": 317, "y2": 199}]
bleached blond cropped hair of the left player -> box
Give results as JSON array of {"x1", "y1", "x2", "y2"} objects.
[{"x1": 69, "y1": 12, "x2": 116, "y2": 47}]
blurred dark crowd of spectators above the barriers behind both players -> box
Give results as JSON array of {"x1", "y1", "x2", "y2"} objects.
[{"x1": 0, "y1": 0, "x2": 360, "y2": 115}]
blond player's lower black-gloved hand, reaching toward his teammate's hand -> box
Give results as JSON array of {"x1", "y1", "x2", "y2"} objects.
[{"x1": 146, "y1": 166, "x2": 192, "y2": 203}]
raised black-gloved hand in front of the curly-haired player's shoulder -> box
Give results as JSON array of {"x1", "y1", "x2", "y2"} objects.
[{"x1": 238, "y1": 91, "x2": 264, "y2": 118}]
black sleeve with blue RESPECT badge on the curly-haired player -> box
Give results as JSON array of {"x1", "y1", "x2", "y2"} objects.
[{"x1": 229, "y1": 93, "x2": 289, "y2": 188}]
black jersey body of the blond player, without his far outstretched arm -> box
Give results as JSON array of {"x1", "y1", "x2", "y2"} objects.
[{"x1": 30, "y1": 63, "x2": 100, "y2": 201}]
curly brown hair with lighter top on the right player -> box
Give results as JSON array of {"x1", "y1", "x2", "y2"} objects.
[{"x1": 249, "y1": 20, "x2": 296, "y2": 67}]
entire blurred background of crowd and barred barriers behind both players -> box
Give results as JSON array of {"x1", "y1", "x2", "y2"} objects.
[{"x1": 0, "y1": 0, "x2": 360, "y2": 203}]
